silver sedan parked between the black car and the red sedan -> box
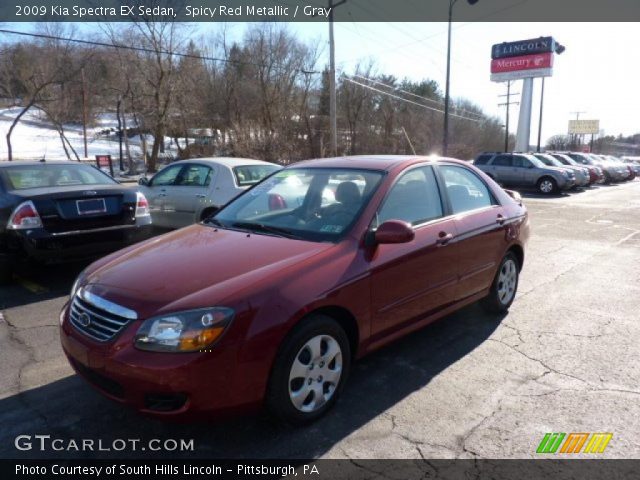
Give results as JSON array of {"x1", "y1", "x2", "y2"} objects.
[{"x1": 138, "y1": 157, "x2": 282, "y2": 228}]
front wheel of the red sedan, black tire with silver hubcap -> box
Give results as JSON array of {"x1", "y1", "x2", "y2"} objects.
[{"x1": 265, "y1": 315, "x2": 351, "y2": 425}]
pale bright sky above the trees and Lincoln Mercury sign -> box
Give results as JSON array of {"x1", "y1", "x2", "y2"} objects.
[{"x1": 5, "y1": 22, "x2": 640, "y2": 145}]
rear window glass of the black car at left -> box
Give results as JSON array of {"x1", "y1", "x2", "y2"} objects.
[{"x1": 0, "y1": 163, "x2": 118, "y2": 190}]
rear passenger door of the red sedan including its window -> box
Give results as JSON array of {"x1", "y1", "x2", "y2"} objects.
[{"x1": 438, "y1": 164, "x2": 506, "y2": 300}]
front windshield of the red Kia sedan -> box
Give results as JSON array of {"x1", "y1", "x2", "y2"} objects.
[{"x1": 215, "y1": 168, "x2": 383, "y2": 242}]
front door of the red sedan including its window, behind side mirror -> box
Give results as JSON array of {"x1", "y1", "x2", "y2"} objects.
[{"x1": 371, "y1": 166, "x2": 458, "y2": 333}]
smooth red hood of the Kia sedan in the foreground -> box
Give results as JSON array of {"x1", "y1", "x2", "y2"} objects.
[{"x1": 83, "y1": 225, "x2": 335, "y2": 318}]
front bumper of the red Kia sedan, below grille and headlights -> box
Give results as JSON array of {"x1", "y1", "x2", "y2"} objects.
[{"x1": 60, "y1": 306, "x2": 250, "y2": 419}]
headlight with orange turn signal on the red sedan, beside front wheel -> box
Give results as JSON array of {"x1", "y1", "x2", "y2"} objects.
[{"x1": 135, "y1": 307, "x2": 235, "y2": 352}]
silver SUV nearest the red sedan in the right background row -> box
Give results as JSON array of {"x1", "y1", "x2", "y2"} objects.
[{"x1": 473, "y1": 152, "x2": 576, "y2": 194}]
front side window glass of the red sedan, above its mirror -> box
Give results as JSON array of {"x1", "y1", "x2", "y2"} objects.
[{"x1": 376, "y1": 166, "x2": 444, "y2": 227}]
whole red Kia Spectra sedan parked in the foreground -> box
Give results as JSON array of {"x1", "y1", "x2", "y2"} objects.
[{"x1": 60, "y1": 156, "x2": 529, "y2": 423}]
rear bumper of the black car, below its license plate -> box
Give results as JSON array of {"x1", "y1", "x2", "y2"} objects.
[{"x1": 6, "y1": 223, "x2": 152, "y2": 263}]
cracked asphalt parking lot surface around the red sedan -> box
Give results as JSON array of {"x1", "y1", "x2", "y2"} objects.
[{"x1": 0, "y1": 181, "x2": 640, "y2": 459}]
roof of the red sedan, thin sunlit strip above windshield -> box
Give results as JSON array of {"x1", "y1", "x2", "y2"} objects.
[{"x1": 291, "y1": 155, "x2": 469, "y2": 170}]
